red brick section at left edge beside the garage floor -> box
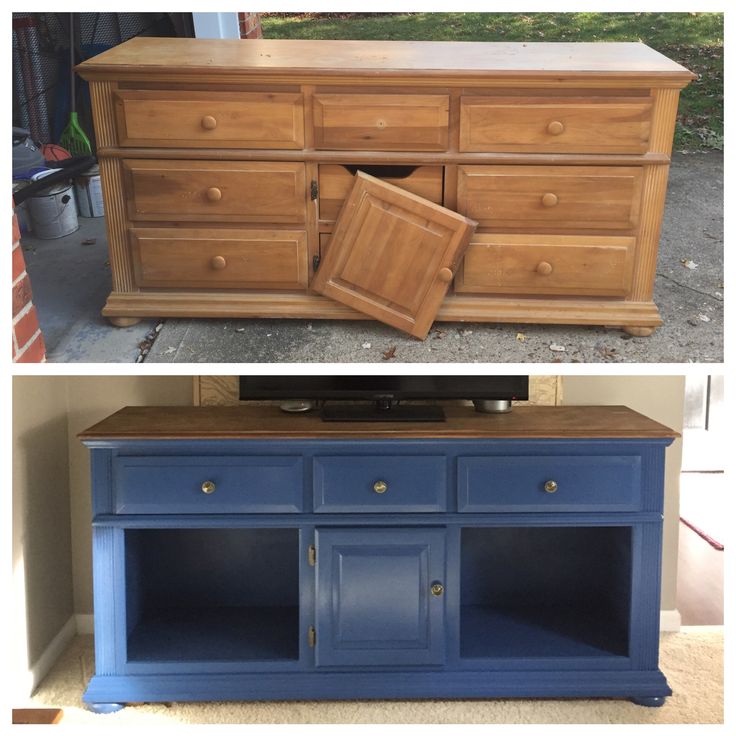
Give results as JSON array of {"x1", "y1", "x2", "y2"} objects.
[{"x1": 13, "y1": 203, "x2": 46, "y2": 363}]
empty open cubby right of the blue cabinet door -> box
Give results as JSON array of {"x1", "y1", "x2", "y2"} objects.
[{"x1": 460, "y1": 527, "x2": 632, "y2": 659}]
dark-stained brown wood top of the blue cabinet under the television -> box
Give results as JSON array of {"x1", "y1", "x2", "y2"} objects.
[{"x1": 79, "y1": 406, "x2": 679, "y2": 441}]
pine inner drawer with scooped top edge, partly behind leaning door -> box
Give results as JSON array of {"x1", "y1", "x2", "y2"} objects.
[{"x1": 319, "y1": 164, "x2": 442, "y2": 221}]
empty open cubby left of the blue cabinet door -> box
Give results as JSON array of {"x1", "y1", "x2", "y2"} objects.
[{"x1": 125, "y1": 529, "x2": 299, "y2": 662}]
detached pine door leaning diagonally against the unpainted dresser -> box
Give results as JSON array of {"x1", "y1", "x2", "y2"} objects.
[{"x1": 312, "y1": 171, "x2": 476, "y2": 339}]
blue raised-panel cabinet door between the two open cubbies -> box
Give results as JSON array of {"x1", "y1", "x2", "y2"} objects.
[{"x1": 316, "y1": 528, "x2": 445, "y2": 667}]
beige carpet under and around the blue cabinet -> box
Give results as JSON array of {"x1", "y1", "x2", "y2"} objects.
[{"x1": 25, "y1": 626, "x2": 723, "y2": 726}]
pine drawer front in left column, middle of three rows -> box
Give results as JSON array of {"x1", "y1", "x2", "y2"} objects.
[{"x1": 124, "y1": 160, "x2": 306, "y2": 223}]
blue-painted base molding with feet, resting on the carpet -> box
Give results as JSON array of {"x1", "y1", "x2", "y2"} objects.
[{"x1": 83, "y1": 669, "x2": 672, "y2": 712}]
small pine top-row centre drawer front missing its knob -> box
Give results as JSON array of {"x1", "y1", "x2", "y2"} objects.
[{"x1": 314, "y1": 94, "x2": 450, "y2": 151}]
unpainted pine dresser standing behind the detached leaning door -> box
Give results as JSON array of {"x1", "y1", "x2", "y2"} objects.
[{"x1": 77, "y1": 38, "x2": 694, "y2": 335}]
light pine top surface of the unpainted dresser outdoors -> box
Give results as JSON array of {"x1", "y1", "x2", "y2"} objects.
[{"x1": 77, "y1": 37, "x2": 695, "y2": 83}]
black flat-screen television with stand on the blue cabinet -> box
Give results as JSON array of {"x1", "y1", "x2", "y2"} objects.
[{"x1": 239, "y1": 375, "x2": 529, "y2": 421}]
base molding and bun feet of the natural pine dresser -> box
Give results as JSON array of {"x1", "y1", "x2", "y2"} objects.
[{"x1": 102, "y1": 292, "x2": 662, "y2": 336}]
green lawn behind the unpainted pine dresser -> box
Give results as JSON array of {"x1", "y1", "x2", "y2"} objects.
[{"x1": 261, "y1": 13, "x2": 723, "y2": 151}]
